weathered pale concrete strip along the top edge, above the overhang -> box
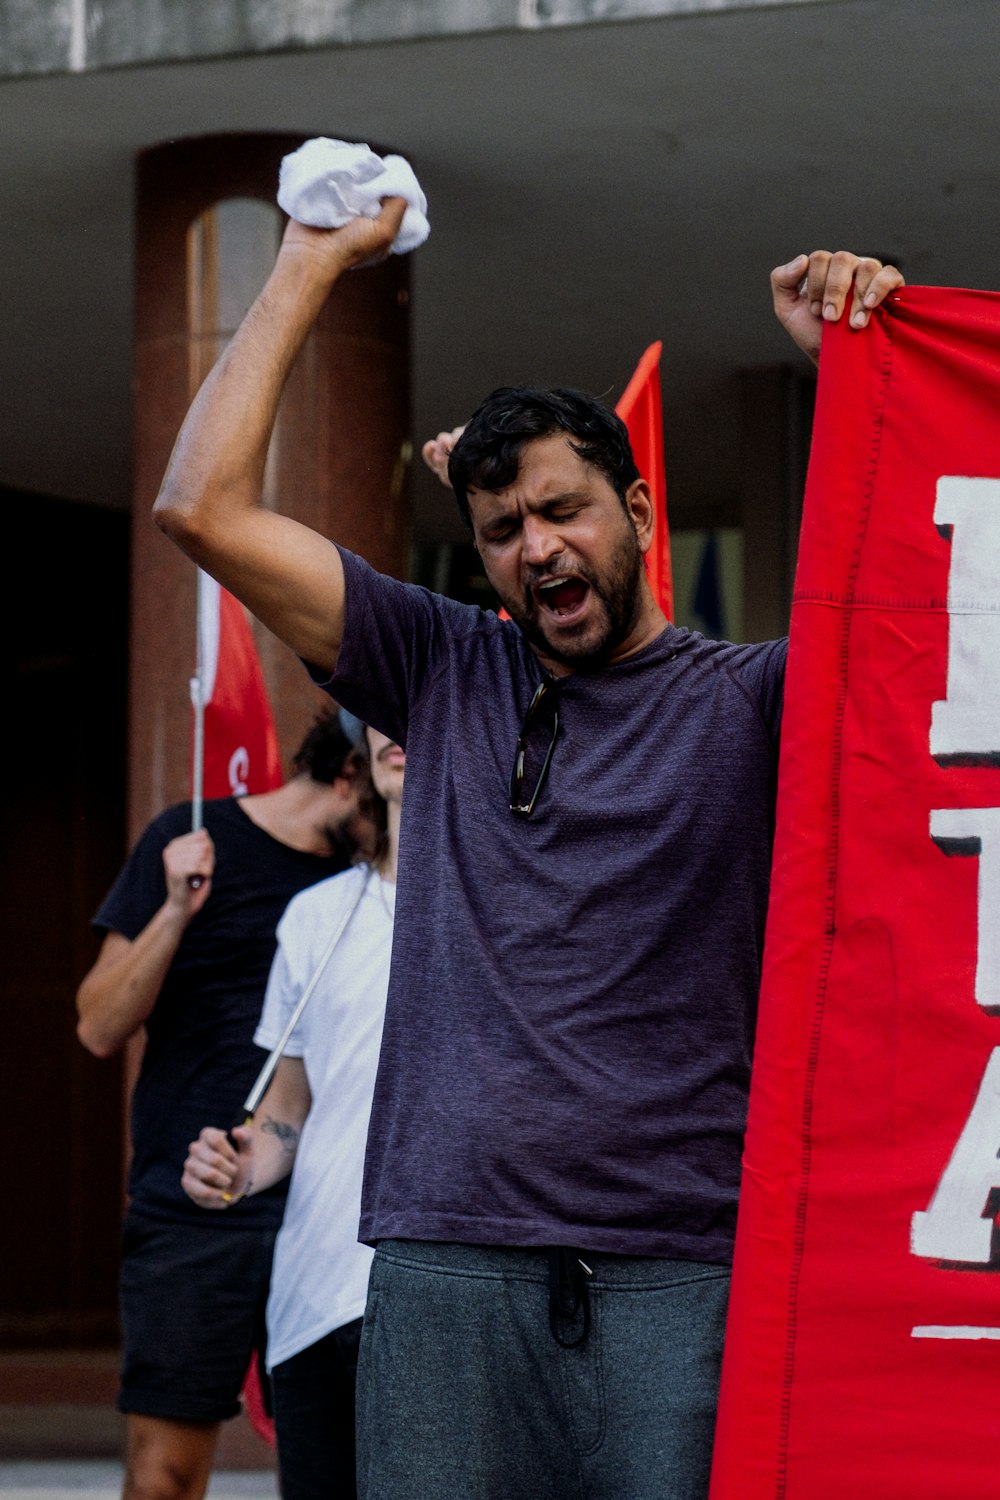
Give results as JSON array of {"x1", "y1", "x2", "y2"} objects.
[{"x1": 0, "y1": 0, "x2": 825, "y2": 78}]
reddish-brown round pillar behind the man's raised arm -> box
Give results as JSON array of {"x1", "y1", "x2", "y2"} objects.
[{"x1": 129, "y1": 135, "x2": 409, "y2": 839}]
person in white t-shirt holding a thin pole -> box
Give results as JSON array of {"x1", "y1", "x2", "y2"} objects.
[{"x1": 181, "y1": 726, "x2": 406, "y2": 1500}]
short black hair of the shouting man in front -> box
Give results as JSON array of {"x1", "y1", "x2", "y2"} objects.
[{"x1": 448, "y1": 386, "x2": 640, "y2": 528}]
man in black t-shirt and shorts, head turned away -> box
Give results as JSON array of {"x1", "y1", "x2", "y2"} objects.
[{"x1": 76, "y1": 716, "x2": 369, "y2": 1500}]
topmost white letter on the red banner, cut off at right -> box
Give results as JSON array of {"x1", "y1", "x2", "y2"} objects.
[{"x1": 931, "y1": 476, "x2": 1000, "y2": 765}]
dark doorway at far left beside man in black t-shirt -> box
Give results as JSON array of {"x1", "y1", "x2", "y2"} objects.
[{"x1": 0, "y1": 491, "x2": 129, "y2": 1349}]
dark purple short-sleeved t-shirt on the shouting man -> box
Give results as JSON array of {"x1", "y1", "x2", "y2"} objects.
[{"x1": 325, "y1": 552, "x2": 786, "y2": 1262}]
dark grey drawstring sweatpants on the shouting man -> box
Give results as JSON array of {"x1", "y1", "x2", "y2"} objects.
[{"x1": 358, "y1": 1241, "x2": 729, "y2": 1500}]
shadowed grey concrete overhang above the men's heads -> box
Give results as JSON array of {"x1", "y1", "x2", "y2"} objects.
[{"x1": 0, "y1": 0, "x2": 1000, "y2": 539}]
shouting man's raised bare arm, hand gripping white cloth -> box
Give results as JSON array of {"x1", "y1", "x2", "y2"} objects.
[{"x1": 153, "y1": 198, "x2": 406, "y2": 671}]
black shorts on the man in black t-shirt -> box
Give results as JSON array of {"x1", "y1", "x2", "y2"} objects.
[{"x1": 118, "y1": 1209, "x2": 277, "y2": 1422}]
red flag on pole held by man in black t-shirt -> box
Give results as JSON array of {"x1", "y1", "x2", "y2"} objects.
[{"x1": 198, "y1": 573, "x2": 282, "y2": 797}]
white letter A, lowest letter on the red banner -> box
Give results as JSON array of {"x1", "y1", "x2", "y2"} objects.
[{"x1": 910, "y1": 1047, "x2": 1000, "y2": 1266}]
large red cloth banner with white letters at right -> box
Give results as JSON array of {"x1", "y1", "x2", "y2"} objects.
[{"x1": 711, "y1": 288, "x2": 1000, "y2": 1500}]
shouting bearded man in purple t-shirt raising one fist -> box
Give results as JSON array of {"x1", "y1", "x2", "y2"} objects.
[{"x1": 156, "y1": 200, "x2": 901, "y2": 1500}]
